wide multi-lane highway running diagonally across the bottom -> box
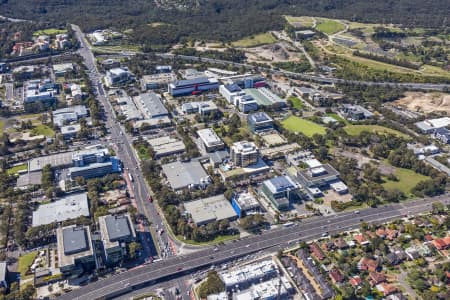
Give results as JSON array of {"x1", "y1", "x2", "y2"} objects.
[{"x1": 60, "y1": 195, "x2": 450, "y2": 300}]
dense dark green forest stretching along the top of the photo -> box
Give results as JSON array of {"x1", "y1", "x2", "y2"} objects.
[{"x1": 0, "y1": 0, "x2": 450, "y2": 45}]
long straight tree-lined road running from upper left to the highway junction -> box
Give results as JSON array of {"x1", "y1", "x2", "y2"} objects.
[{"x1": 72, "y1": 25, "x2": 172, "y2": 258}]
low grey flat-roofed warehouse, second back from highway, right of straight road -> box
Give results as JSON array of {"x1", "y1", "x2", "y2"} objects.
[{"x1": 162, "y1": 161, "x2": 211, "y2": 190}]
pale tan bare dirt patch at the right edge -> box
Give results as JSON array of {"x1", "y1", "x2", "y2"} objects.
[{"x1": 394, "y1": 92, "x2": 450, "y2": 114}]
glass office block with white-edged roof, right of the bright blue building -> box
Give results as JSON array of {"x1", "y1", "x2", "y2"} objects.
[{"x1": 261, "y1": 176, "x2": 299, "y2": 210}]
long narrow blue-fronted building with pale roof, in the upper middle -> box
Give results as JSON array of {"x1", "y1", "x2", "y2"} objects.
[{"x1": 168, "y1": 77, "x2": 219, "y2": 96}]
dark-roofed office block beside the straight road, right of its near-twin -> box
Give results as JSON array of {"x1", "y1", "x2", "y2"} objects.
[{"x1": 98, "y1": 214, "x2": 136, "y2": 265}]
